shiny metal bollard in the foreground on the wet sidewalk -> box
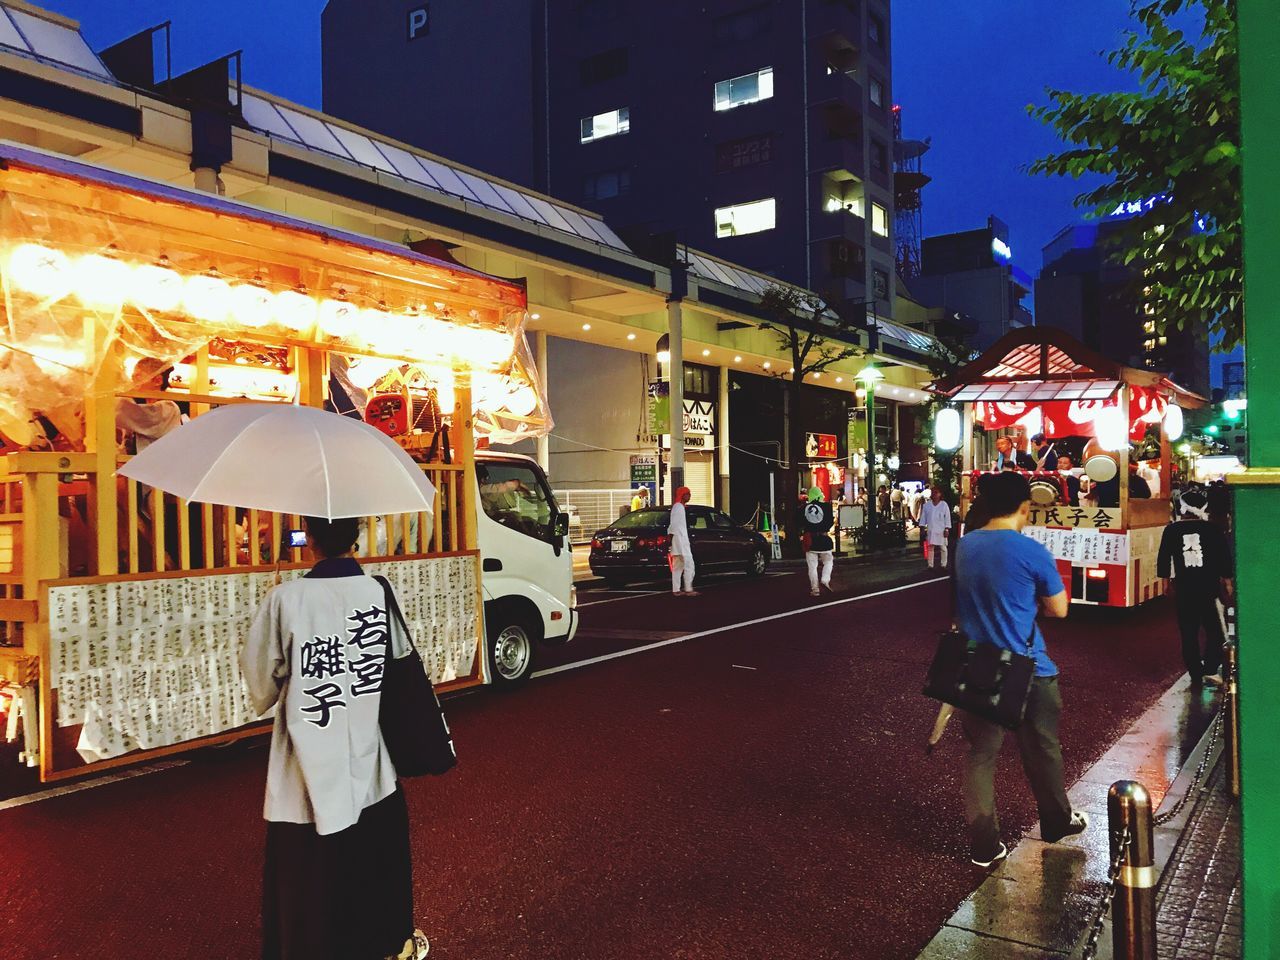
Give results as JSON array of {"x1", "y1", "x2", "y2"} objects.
[{"x1": 1107, "y1": 780, "x2": 1156, "y2": 960}]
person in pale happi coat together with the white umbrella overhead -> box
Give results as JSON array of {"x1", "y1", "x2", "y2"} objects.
[{"x1": 118, "y1": 403, "x2": 452, "y2": 960}]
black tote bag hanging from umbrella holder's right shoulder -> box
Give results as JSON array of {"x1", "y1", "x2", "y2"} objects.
[{"x1": 374, "y1": 577, "x2": 458, "y2": 777}]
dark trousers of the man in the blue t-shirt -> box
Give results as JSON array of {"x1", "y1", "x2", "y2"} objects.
[{"x1": 960, "y1": 677, "x2": 1071, "y2": 860}]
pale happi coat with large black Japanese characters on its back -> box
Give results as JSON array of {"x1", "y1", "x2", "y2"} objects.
[{"x1": 241, "y1": 558, "x2": 411, "y2": 835}]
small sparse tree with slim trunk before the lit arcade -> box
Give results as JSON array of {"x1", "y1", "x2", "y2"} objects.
[{"x1": 760, "y1": 285, "x2": 864, "y2": 557}]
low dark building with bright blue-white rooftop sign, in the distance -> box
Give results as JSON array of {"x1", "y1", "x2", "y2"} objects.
[{"x1": 910, "y1": 216, "x2": 1033, "y2": 351}]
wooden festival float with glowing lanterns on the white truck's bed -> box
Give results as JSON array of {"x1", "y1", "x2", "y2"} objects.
[{"x1": 0, "y1": 146, "x2": 550, "y2": 781}]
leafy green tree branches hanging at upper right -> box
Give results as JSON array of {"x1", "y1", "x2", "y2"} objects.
[{"x1": 1028, "y1": 0, "x2": 1244, "y2": 349}]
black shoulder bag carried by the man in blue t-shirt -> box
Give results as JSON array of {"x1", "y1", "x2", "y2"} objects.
[{"x1": 924, "y1": 622, "x2": 1036, "y2": 730}]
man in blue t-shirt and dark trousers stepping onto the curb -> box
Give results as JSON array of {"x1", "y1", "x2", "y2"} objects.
[{"x1": 955, "y1": 472, "x2": 1089, "y2": 867}]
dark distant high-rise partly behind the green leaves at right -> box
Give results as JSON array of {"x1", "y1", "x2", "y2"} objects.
[{"x1": 1036, "y1": 220, "x2": 1210, "y2": 397}]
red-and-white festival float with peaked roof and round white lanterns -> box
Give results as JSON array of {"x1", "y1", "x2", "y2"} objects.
[{"x1": 931, "y1": 326, "x2": 1206, "y2": 607}]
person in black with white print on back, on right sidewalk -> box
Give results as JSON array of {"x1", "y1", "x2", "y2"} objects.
[{"x1": 1156, "y1": 488, "x2": 1231, "y2": 686}]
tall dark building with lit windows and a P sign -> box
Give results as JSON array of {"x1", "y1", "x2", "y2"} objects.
[{"x1": 321, "y1": 0, "x2": 893, "y2": 316}]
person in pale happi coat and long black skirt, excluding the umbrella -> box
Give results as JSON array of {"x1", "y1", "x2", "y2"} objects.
[{"x1": 241, "y1": 517, "x2": 429, "y2": 960}]
